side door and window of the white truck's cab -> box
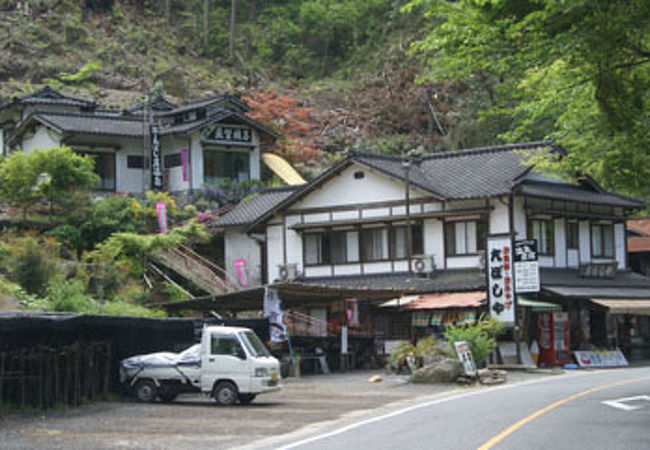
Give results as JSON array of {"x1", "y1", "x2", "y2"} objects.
[{"x1": 201, "y1": 331, "x2": 252, "y2": 392}]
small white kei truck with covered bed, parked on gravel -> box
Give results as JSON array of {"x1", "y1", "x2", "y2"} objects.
[{"x1": 120, "y1": 326, "x2": 281, "y2": 405}]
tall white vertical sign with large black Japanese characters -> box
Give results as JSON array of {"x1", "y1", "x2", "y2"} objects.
[{"x1": 485, "y1": 236, "x2": 515, "y2": 325}]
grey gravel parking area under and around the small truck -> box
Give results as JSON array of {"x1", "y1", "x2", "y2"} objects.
[{"x1": 0, "y1": 371, "x2": 548, "y2": 450}]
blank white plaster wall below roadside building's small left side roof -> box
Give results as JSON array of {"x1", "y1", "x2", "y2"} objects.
[{"x1": 224, "y1": 229, "x2": 262, "y2": 286}]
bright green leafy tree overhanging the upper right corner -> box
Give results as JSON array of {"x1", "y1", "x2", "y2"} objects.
[{"x1": 406, "y1": 0, "x2": 650, "y2": 197}]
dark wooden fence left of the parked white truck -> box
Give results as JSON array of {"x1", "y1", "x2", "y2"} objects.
[{"x1": 0, "y1": 342, "x2": 111, "y2": 409}]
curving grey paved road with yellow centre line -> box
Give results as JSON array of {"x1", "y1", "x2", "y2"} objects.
[{"x1": 251, "y1": 368, "x2": 650, "y2": 450}]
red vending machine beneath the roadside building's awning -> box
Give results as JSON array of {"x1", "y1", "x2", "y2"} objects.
[{"x1": 537, "y1": 312, "x2": 571, "y2": 366}]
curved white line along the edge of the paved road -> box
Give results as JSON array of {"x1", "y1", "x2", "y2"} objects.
[{"x1": 277, "y1": 371, "x2": 604, "y2": 450}]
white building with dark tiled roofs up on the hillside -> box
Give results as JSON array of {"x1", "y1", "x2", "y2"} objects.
[{"x1": 0, "y1": 87, "x2": 276, "y2": 193}]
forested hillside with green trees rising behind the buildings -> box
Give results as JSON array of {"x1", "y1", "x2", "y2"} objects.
[{"x1": 0, "y1": 0, "x2": 650, "y2": 198}]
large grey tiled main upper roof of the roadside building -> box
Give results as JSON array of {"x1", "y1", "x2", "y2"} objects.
[{"x1": 240, "y1": 141, "x2": 644, "y2": 232}]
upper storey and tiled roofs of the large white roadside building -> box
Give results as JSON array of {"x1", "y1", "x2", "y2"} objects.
[{"x1": 208, "y1": 142, "x2": 650, "y2": 352}]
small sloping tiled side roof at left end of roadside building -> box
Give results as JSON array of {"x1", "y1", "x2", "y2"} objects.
[{"x1": 210, "y1": 186, "x2": 300, "y2": 228}]
